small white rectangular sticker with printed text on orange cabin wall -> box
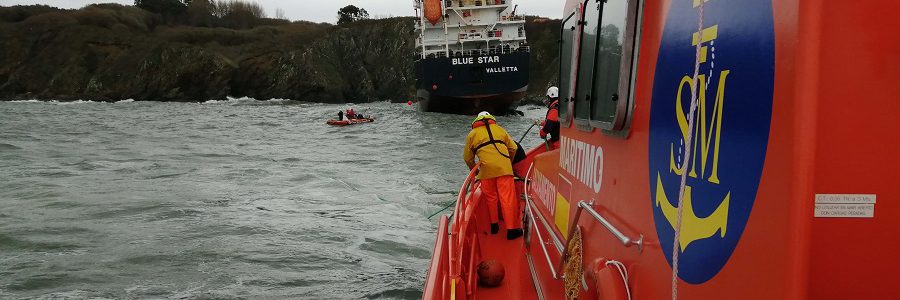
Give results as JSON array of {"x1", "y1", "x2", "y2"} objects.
[{"x1": 816, "y1": 194, "x2": 875, "y2": 218}]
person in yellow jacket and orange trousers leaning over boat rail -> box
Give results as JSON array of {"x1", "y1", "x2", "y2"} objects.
[{"x1": 463, "y1": 112, "x2": 522, "y2": 240}]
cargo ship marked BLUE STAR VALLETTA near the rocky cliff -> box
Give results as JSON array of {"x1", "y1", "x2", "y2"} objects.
[{"x1": 415, "y1": 0, "x2": 529, "y2": 115}]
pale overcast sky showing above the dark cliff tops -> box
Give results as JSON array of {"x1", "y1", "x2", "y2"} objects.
[{"x1": 0, "y1": 0, "x2": 565, "y2": 23}]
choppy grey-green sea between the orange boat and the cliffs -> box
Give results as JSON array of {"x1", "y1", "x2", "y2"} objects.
[{"x1": 0, "y1": 98, "x2": 543, "y2": 299}]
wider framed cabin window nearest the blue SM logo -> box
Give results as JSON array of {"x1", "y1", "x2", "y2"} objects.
[{"x1": 574, "y1": 0, "x2": 640, "y2": 132}]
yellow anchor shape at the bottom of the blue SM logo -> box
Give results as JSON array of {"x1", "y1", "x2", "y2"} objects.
[{"x1": 656, "y1": 172, "x2": 731, "y2": 252}]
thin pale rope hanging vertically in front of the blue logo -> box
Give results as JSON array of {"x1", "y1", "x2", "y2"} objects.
[{"x1": 676, "y1": 1, "x2": 705, "y2": 300}]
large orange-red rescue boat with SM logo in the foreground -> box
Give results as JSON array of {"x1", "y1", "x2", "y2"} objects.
[{"x1": 422, "y1": 0, "x2": 900, "y2": 300}]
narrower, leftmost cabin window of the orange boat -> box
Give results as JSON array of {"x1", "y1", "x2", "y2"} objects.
[{"x1": 559, "y1": 12, "x2": 581, "y2": 126}]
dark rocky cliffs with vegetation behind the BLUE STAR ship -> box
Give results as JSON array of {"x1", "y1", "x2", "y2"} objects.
[{"x1": 0, "y1": 0, "x2": 559, "y2": 103}]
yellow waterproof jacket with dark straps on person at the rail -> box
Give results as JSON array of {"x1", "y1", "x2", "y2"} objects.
[{"x1": 463, "y1": 120, "x2": 518, "y2": 179}]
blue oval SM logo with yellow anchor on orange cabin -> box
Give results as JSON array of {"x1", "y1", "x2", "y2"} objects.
[{"x1": 649, "y1": 0, "x2": 775, "y2": 284}]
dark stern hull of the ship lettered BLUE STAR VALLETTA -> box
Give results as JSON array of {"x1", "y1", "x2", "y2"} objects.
[{"x1": 416, "y1": 52, "x2": 529, "y2": 115}]
